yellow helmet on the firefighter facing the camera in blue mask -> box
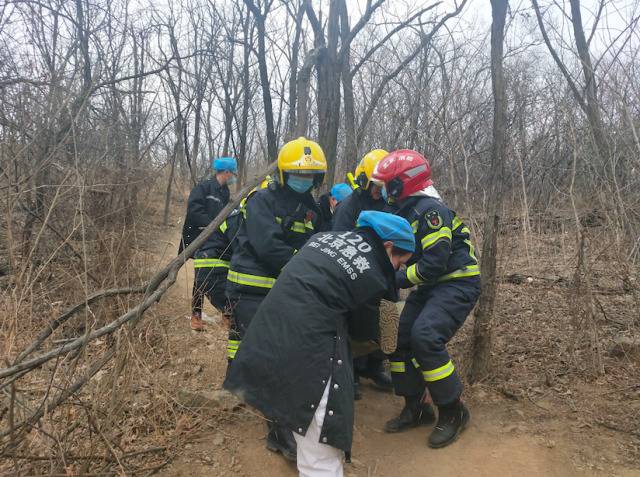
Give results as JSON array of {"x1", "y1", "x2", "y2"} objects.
[{"x1": 278, "y1": 136, "x2": 327, "y2": 186}]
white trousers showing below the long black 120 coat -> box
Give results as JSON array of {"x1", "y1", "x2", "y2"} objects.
[{"x1": 293, "y1": 380, "x2": 344, "y2": 477}]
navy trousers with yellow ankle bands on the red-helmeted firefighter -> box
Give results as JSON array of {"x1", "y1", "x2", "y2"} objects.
[{"x1": 389, "y1": 277, "x2": 480, "y2": 406}]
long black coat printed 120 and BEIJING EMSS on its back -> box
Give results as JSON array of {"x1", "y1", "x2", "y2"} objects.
[{"x1": 224, "y1": 229, "x2": 395, "y2": 452}]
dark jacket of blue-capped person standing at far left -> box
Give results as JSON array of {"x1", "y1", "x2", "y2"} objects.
[{"x1": 178, "y1": 177, "x2": 230, "y2": 253}]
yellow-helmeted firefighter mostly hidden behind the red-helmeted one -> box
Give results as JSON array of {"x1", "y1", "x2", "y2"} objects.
[{"x1": 333, "y1": 149, "x2": 393, "y2": 399}]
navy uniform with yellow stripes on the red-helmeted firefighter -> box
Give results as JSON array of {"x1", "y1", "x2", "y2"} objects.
[{"x1": 390, "y1": 195, "x2": 480, "y2": 406}]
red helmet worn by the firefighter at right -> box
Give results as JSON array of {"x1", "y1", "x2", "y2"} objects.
[{"x1": 372, "y1": 149, "x2": 433, "y2": 199}]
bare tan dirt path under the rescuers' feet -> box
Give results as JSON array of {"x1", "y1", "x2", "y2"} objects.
[{"x1": 152, "y1": 227, "x2": 640, "y2": 477}]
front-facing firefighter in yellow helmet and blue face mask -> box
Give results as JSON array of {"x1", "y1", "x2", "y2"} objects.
[{"x1": 227, "y1": 137, "x2": 327, "y2": 461}]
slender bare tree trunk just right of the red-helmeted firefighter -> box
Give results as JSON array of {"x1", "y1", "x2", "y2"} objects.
[{"x1": 469, "y1": 0, "x2": 508, "y2": 382}]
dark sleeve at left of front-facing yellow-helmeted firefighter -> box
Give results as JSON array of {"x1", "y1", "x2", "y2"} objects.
[{"x1": 245, "y1": 193, "x2": 295, "y2": 273}]
